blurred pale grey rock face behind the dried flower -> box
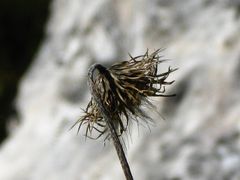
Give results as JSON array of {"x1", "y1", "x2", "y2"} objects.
[{"x1": 0, "y1": 0, "x2": 240, "y2": 180}]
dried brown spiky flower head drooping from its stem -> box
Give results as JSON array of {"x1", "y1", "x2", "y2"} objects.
[{"x1": 74, "y1": 49, "x2": 177, "y2": 138}]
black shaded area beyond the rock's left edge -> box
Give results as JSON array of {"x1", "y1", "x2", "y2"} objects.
[{"x1": 0, "y1": 0, "x2": 50, "y2": 143}]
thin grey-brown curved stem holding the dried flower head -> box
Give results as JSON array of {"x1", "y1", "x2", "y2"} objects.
[{"x1": 88, "y1": 64, "x2": 133, "y2": 180}]
